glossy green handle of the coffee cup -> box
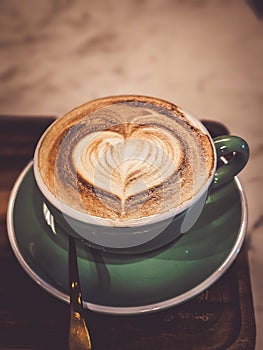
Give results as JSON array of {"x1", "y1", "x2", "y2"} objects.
[{"x1": 212, "y1": 135, "x2": 249, "y2": 188}]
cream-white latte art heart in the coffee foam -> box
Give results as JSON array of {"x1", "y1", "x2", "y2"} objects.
[{"x1": 73, "y1": 125, "x2": 182, "y2": 212}]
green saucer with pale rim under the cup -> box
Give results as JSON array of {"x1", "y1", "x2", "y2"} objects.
[{"x1": 7, "y1": 163, "x2": 247, "y2": 314}]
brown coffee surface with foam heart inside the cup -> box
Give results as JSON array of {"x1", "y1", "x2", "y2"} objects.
[{"x1": 38, "y1": 96, "x2": 214, "y2": 221}]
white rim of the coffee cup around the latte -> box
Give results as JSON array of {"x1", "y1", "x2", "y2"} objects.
[{"x1": 33, "y1": 95, "x2": 217, "y2": 228}]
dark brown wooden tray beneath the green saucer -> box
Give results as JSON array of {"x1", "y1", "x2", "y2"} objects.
[{"x1": 0, "y1": 116, "x2": 255, "y2": 350}]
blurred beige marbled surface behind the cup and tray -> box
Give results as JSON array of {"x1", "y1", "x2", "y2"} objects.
[{"x1": 0, "y1": 0, "x2": 263, "y2": 350}]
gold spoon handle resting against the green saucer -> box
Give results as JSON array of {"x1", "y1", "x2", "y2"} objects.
[{"x1": 68, "y1": 237, "x2": 91, "y2": 350}]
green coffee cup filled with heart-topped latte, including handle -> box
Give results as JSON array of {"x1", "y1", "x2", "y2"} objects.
[{"x1": 34, "y1": 95, "x2": 249, "y2": 253}]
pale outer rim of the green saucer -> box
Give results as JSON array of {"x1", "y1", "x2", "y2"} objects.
[{"x1": 6, "y1": 161, "x2": 248, "y2": 315}]
